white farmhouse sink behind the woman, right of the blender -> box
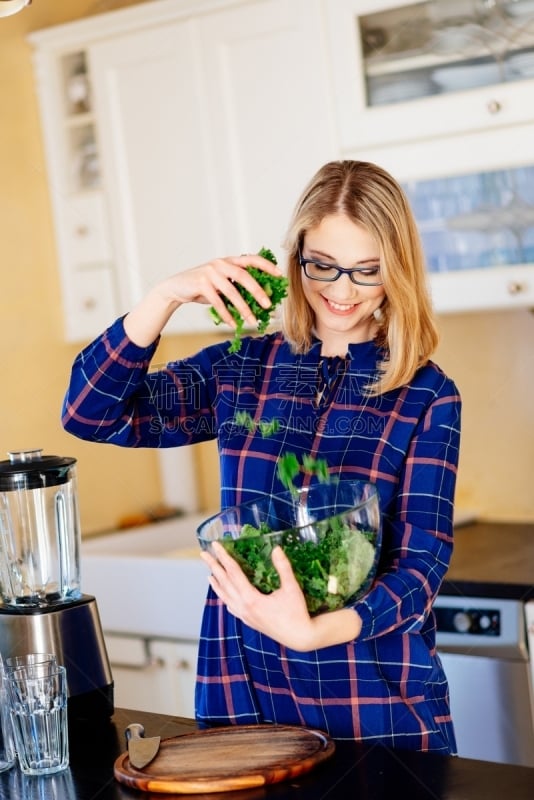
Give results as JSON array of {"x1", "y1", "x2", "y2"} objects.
[{"x1": 81, "y1": 513, "x2": 210, "y2": 640}]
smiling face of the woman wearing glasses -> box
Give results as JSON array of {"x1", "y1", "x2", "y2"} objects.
[{"x1": 301, "y1": 214, "x2": 386, "y2": 356}]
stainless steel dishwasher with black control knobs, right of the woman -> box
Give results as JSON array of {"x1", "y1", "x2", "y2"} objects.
[{"x1": 434, "y1": 595, "x2": 534, "y2": 767}]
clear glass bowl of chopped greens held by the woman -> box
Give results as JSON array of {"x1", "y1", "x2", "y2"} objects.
[{"x1": 197, "y1": 480, "x2": 382, "y2": 614}]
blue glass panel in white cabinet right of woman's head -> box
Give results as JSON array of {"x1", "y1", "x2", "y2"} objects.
[{"x1": 403, "y1": 166, "x2": 534, "y2": 272}]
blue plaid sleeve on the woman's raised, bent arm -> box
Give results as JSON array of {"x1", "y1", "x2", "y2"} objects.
[{"x1": 62, "y1": 318, "x2": 220, "y2": 447}]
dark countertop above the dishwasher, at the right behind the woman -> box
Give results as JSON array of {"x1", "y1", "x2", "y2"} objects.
[{"x1": 441, "y1": 522, "x2": 534, "y2": 600}]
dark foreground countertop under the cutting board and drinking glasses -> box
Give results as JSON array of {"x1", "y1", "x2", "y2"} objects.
[{"x1": 0, "y1": 709, "x2": 534, "y2": 800}]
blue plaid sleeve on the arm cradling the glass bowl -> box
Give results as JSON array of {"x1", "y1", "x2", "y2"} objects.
[{"x1": 354, "y1": 378, "x2": 461, "y2": 639}]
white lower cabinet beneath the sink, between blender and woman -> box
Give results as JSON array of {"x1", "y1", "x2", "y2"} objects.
[{"x1": 104, "y1": 631, "x2": 198, "y2": 718}]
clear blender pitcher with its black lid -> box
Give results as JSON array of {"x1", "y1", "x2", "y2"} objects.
[{"x1": 0, "y1": 449, "x2": 82, "y2": 608}]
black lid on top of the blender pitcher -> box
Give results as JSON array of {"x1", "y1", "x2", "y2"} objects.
[{"x1": 0, "y1": 449, "x2": 76, "y2": 492}]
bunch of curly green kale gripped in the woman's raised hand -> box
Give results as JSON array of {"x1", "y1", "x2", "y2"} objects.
[{"x1": 209, "y1": 247, "x2": 288, "y2": 353}]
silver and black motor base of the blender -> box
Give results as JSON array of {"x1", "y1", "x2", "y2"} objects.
[{"x1": 0, "y1": 595, "x2": 114, "y2": 720}]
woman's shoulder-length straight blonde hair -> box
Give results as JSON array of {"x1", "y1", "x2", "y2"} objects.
[{"x1": 282, "y1": 160, "x2": 438, "y2": 395}]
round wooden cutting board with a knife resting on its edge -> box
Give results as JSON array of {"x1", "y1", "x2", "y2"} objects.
[{"x1": 114, "y1": 725, "x2": 335, "y2": 794}]
